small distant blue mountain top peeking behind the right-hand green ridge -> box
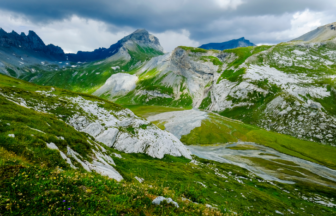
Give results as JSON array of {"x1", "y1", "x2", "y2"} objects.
[{"x1": 200, "y1": 37, "x2": 255, "y2": 50}]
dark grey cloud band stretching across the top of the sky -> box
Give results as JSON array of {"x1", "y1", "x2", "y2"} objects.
[{"x1": 0, "y1": 0, "x2": 335, "y2": 46}]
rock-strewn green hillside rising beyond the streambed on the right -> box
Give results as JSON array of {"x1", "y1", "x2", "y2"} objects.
[{"x1": 107, "y1": 42, "x2": 336, "y2": 145}]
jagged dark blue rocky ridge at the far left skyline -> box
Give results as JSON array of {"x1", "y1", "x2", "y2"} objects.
[{"x1": 0, "y1": 28, "x2": 65, "y2": 60}]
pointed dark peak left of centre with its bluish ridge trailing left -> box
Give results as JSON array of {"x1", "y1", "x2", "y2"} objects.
[{"x1": 66, "y1": 29, "x2": 163, "y2": 62}]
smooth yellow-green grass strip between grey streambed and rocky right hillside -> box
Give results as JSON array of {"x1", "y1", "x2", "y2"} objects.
[{"x1": 181, "y1": 114, "x2": 336, "y2": 169}]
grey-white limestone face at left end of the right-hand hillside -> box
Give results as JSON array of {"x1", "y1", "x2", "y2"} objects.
[{"x1": 137, "y1": 47, "x2": 222, "y2": 108}]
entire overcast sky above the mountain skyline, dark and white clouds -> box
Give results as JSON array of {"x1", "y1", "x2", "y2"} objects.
[{"x1": 0, "y1": 0, "x2": 336, "y2": 52}]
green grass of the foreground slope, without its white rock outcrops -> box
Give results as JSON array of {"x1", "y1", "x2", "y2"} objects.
[{"x1": 0, "y1": 76, "x2": 336, "y2": 215}]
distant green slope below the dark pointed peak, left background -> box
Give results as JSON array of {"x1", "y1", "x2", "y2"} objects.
[{"x1": 20, "y1": 45, "x2": 163, "y2": 94}]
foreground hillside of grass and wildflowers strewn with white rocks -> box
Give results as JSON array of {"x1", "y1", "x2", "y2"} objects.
[{"x1": 0, "y1": 75, "x2": 336, "y2": 215}]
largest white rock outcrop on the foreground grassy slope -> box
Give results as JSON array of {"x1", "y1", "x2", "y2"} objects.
[{"x1": 69, "y1": 97, "x2": 191, "y2": 159}]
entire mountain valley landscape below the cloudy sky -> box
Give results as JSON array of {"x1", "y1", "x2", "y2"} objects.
[{"x1": 0, "y1": 24, "x2": 336, "y2": 215}]
